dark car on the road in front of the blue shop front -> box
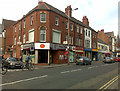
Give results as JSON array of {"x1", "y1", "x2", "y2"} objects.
[{"x1": 76, "y1": 56, "x2": 91, "y2": 65}]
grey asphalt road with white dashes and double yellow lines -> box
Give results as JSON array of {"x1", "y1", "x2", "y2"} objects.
[{"x1": 0, "y1": 62, "x2": 120, "y2": 91}]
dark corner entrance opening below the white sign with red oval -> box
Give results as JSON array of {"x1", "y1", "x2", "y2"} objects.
[{"x1": 38, "y1": 50, "x2": 48, "y2": 63}]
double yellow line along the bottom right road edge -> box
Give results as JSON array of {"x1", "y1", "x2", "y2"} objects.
[{"x1": 98, "y1": 75, "x2": 119, "y2": 91}]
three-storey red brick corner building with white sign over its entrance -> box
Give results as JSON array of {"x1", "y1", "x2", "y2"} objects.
[{"x1": 13, "y1": 2, "x2": 96, "y2": 64}]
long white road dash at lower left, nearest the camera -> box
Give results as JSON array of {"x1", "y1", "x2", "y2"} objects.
[{"x1": 0, "y1": 75, "x2": 48, "y2": 86}]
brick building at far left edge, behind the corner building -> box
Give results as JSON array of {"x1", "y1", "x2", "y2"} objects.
[{"x1": 1, "y1": 19, "x2": 16, "y2": 58}]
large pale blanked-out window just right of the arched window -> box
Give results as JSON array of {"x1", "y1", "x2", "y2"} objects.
[{"x1": 53, "y1": 30, "x2": 61, "y2": 43}]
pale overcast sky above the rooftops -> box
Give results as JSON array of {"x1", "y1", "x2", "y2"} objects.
[{"x1": 0, "y1": 0, "x2": 119, "y2": 35}]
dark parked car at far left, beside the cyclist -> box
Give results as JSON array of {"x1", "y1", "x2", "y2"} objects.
[{"x1": 5, "y1": 57, "x2": 23, "y2": 68}]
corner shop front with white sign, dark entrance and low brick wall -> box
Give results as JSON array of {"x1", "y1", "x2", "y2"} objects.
[{"x1": 35, "y1": 43, "x2": 75, "y2": 64}]
